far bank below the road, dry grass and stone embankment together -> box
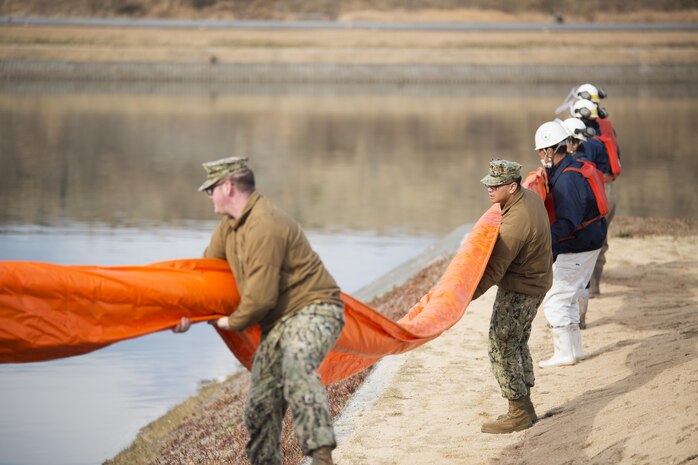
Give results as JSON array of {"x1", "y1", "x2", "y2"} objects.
[{"x1": 0, "y1": 19, "x2": 698, "y2": 85}]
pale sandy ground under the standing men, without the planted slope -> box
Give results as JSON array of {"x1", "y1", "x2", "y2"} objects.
[{"x1": 335, "y1": 232, "x2": 698, "y2": 465}]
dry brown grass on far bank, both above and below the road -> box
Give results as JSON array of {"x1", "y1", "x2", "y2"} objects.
[{"x1": 0, "y1": 0, "x2": 698, "y2": 65}]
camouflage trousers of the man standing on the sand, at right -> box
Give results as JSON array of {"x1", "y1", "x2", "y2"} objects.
[{"x1": 489, "y1": 287, "x2": 544, "y2": 400}]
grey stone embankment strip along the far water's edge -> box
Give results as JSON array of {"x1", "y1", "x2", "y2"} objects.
[{"x1": 0, "y1": 59, "x2": 698, "y2": 85}]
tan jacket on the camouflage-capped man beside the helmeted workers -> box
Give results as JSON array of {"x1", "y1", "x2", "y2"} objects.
[{"x1": 473, "y1": 188, "x2": 553, "y2": 299}]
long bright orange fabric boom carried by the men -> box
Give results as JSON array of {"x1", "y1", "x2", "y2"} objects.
[{"x1": 0, "y1": 205, "x2": 501, "y2": 384}]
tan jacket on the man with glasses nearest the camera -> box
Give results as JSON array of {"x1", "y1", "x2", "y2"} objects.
[{"x1": 204, "y1": 192, "x2": 344, "y2": 333}]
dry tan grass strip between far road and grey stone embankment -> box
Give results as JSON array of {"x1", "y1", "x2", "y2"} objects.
[{"x1": 0, "y1": 26, "x2": 698, "y2": 65}]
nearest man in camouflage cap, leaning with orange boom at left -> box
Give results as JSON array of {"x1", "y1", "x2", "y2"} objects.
[{"x1": 175, "y1": 157, "x2": 344, "y2": 465}]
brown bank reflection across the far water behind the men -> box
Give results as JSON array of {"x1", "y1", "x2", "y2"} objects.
[{"x1": 0, "y1": 86, "x2": 698, "y2": 233}]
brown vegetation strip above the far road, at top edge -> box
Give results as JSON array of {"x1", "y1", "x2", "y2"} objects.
[{"x1": 0, "y1": 0, "x2": 696, "y2": 22}]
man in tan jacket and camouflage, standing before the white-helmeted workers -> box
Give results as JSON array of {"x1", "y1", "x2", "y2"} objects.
[{"x1": 473, "y1": 160, "x2": 553, "y2": 433}]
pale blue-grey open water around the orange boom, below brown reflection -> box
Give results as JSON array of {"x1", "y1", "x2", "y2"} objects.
[{"x1": 0, "y1": 222, "x2": 434, "y2": 465}]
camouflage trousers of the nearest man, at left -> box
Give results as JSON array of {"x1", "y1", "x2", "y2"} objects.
[{"x1": 245, "y1": 304, "x2": 344, "y2": 465}]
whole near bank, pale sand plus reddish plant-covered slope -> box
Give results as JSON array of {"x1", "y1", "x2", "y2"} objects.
[{"x1": 109, "y1": 217, "x2": 698, "y2": 465}]
